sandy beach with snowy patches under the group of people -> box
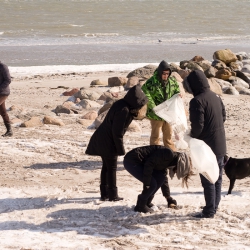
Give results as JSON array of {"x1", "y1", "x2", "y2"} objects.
[{"x1": 0, "y1": 72, "x2": 250, "y2": 250}]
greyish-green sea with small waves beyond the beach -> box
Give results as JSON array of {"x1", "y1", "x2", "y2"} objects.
[{"x1": 0, "y1": 0, "x2": 250, "y2": 69}]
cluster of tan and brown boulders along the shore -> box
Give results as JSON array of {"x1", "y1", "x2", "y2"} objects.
[{"x1": 12, "y1": 49, "x2": 250, "y2": 132}]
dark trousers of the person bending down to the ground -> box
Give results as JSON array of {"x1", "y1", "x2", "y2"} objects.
[{"x1": 123, "y1": 159, "x2": 165, "y2": 200}]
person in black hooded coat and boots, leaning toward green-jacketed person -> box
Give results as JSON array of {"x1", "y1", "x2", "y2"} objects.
[{"x1": 86, "y1": 85, "x2": 148, "y2": 201}]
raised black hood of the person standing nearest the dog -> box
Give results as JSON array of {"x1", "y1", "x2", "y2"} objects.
[{"x1": 185, "y1": 69, "x2": 210, "y2": 96}]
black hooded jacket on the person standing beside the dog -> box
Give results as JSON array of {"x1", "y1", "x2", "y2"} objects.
[{"x1": 186, "y1": 70, "x2": 226, "y2": 157}]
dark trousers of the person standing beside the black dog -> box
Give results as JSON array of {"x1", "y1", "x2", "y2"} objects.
[{"x1": 200, "y1": 157, "x2": 224, "y2": 216}]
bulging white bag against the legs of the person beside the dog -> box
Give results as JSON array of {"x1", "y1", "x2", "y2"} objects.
[{"x1": 189, "y1": 138, "x2": 219, "y2": 184}]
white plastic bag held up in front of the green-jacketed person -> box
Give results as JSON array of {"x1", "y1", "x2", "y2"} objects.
[{"x1": 153, "y1": 94, "x2": 188, "y2": 150}]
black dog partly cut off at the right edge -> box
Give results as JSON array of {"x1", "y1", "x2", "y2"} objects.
[{"x1": 224, "y1": 155, "x2": 250, "y2": 194}]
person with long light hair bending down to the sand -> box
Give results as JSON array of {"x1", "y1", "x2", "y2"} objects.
[{"x1": 123, "y1": 145, "x2": 193, "y2": 213}]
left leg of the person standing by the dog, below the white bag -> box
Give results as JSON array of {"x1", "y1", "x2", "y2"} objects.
[{"x1": 200, "y1": 174, "x2": 215, "y2": 217}]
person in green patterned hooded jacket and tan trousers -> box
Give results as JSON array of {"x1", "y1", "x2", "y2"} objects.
[{"x1": 142, "y1": 61, "x2": 180, "y2": 151}]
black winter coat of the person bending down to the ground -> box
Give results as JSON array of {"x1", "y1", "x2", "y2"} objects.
[{"x1": 124, "y1": 145, "x2": 178, "y2": 186}]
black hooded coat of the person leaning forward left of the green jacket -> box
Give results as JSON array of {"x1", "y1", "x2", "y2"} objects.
[{"x1": 86, "y1": 85, "x2": 148, "y2": 157}]
